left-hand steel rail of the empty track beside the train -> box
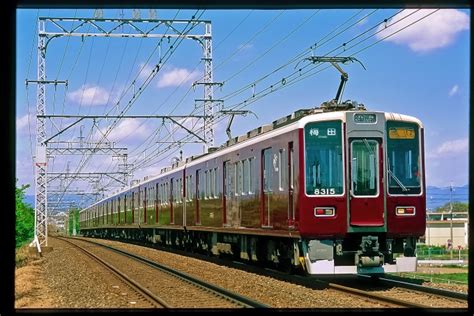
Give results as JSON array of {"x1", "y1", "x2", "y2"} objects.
[{"x1": 54, "y1": 237, "x2": 171, "y2": 308}]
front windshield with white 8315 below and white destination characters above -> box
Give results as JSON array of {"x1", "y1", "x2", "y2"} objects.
[{"x1": 305, "y1": 121, "x2": 343, "y2": 195}]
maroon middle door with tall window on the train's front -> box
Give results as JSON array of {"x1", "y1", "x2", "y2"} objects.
[{"x1": 349, "y1": 138, "x2": 384, "y2": 226}]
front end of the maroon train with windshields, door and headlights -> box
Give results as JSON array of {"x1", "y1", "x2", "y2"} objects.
[{"x1": 299, "y1": 111, "x2": 426, "y2": 274}]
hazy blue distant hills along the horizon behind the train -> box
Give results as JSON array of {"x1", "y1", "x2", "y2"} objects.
[{"x1": 25, "y1": 185, "x2": 469, "y2": 214}]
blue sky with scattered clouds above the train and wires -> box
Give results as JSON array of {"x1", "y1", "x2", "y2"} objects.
[{"x1": 16, "y1": 9, "x2": 470, "y2": 198}]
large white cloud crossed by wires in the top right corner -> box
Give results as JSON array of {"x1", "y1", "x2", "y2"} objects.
[{"x1": 377, "y1": 9, "x2": 469, "y2": 52}]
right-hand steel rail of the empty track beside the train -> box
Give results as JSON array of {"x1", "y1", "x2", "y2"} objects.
[{"x1": 73, "y1": 238, "x2": 270, "y2": 308}]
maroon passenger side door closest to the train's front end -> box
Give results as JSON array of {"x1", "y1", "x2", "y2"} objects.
[{"x1": 260, "y1": 148, "x2": 272, "y2": 227}]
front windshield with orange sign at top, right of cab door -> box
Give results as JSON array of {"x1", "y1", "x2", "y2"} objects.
[{"x1": 387, "y1": 121, "x2": 421, "y2": 194}]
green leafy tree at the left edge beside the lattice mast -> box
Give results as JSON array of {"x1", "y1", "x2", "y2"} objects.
[{"x1": 15, "y1": 180, "x2": 35, "y2": 248}]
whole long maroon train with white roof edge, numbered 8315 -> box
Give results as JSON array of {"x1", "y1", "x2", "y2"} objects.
[{"x1": 80, "y1": 103, "x2": 426, "y2": 274}]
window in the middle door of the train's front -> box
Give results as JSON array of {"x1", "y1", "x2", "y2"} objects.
[{"x1": 351, "y1": 138, "x2": 379, "y2": 196}]
